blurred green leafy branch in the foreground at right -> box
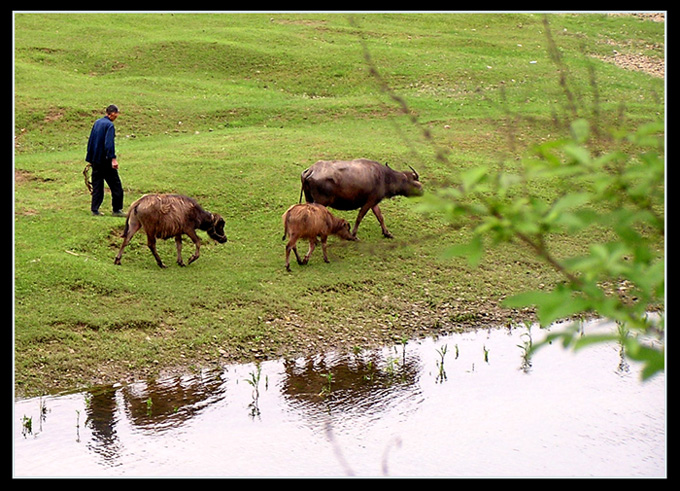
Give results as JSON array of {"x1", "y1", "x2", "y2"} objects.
[{"x1": 362, "y1": 13, "x2": 665, "y2": 378}]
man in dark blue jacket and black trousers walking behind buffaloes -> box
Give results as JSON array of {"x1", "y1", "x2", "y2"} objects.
[{"x1": 85, "y1": 104, "x2": 125, "y2": 216}]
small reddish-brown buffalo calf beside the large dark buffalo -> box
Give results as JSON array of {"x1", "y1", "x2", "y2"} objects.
[{"x1": 282, "y1": 203, "x2": 355, "y2": 271}]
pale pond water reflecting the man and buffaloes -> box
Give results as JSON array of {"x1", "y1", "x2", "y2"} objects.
[{"x1": 13, "y1": 323, "x2": 667, "y2": 478}]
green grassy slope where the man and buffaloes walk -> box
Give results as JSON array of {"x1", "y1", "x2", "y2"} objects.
[{"x1": 14, "y1": 13, "x2": 664, "y2": 395}]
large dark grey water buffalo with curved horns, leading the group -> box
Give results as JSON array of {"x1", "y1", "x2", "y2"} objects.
[{"x1": 300, "y1": 159, "x2": 423, "y2": 237}]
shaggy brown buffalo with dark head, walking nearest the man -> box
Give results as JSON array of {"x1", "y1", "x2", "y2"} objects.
[{"x1": 114, "y1": 194, "x2": 227, "y2": 268}]
